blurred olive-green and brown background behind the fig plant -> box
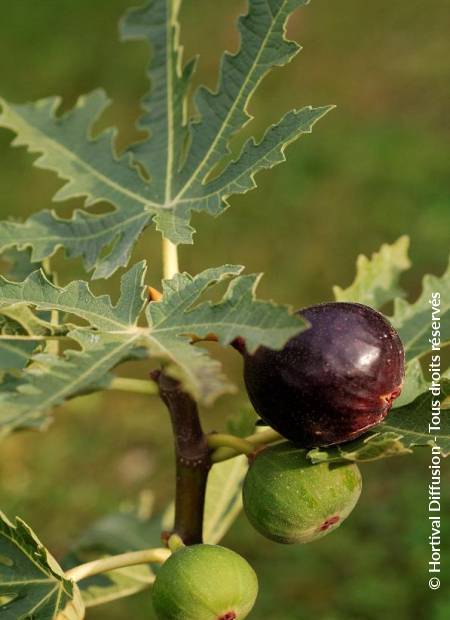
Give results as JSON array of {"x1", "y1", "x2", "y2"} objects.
[{"x1": 0, "y1": 0, "x2": 450, "y2": 620}]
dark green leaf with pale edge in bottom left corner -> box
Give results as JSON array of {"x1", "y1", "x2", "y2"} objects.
[{"x1": 0, "y1": 513, "x2": 84, "y2": 620}]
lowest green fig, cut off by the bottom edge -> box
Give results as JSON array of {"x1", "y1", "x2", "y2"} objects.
[{"x1": 153, "y1": 544, "x2": 258, "y2": 620}]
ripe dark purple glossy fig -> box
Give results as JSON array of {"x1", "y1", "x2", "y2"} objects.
[{"x1": 241, "y1": 302, "x2": 404, "y2": 448}]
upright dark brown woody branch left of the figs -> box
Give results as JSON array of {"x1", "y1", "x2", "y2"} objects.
[{"x1": 152, "y1": 372, "x2": 211, "y2": 545}]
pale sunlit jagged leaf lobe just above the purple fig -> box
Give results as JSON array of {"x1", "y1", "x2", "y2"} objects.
[{"x1": 333, "y1": 236, "x2": 411, "y2": 308}]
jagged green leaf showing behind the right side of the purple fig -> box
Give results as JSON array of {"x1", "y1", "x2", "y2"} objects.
[{"x1": 309, "y1": 237, "x2": 450, "y2": 462}]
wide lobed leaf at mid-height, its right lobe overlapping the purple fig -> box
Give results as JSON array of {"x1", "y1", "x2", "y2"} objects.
[{"x1": 0, "y1": 262, "x2": 303, "y2": 436}]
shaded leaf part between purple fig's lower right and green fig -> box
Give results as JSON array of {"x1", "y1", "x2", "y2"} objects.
[{"x1": 308, "y1": 376, "x2": 450, "y2": 463}]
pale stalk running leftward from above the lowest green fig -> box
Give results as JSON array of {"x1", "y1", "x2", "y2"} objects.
[{"x1": 65, "y1": 548, "x2": 171, "y2": 582}]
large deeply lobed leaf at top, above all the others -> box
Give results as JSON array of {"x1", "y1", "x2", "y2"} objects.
[{"x1": 0, "y1": 0, "x2": 332, "y2": 278}]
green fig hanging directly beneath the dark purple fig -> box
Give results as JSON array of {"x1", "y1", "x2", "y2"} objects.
[{"x1": 243, "y1": 441, "x2": 362, "y2": 544}]
